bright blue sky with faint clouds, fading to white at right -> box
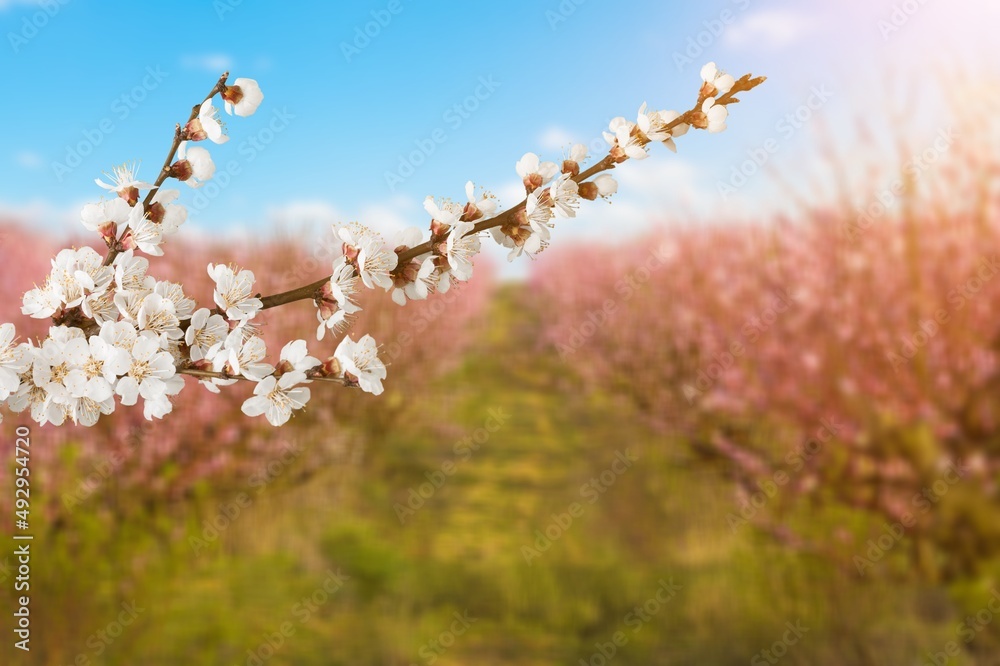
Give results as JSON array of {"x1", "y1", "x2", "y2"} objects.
[{"x1": 0, "y1": 0, "x2": 1000, "y2": 272}]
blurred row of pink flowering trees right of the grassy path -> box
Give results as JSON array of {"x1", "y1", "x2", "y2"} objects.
[{"x1": 531, "y1": 132, "x2": 1000, "y2": 578}]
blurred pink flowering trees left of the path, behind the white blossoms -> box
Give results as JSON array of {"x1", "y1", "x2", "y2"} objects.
[{"x1": 0, "y1": 222, "x2": 492, "y2": 517}]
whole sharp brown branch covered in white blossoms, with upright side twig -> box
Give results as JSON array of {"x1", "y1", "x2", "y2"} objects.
[{"x1": 0, "y1": 63, "x2": 764, "y2": 426}]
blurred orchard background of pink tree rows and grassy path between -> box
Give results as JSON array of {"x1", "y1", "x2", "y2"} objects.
[{"x1": 0, "y1": 85, "x2": 1000, "y2": 665}]
